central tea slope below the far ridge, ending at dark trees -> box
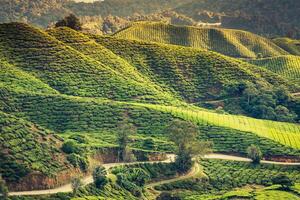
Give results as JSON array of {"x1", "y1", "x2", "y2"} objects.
[{"x1": 90, "y1": 36, "x2": 293, "y2": 102}]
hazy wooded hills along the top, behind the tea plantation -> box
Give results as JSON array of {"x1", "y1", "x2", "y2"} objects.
[{"x1": 0, "y1": 0, "x2": 300, "y2": 38}]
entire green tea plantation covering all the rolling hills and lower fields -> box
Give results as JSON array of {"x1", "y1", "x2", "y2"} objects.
[{"x1": 0, "y1": 22, "x2": 300, "y2": 200}]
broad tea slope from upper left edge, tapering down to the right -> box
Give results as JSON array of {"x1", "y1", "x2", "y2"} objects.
[{"x1": 0, "y1": 23, "x2": 177, "y2": 104}]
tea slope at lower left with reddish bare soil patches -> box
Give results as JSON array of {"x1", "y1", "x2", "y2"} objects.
[{"x1": 0, "y1": 112, "x2": 66, "y2": 183}]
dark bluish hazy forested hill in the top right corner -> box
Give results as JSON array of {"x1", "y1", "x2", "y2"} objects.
[{"x1": 175, "y1": 0, "x2": 300, "y2": 38}]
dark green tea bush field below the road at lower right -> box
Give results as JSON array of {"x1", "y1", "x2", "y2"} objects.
[{"x1": 201, "y1": 160, "x2": 300, "y2": 190}]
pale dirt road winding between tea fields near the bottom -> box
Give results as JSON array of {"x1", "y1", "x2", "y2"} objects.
[{"x1": 9, "y1": 154, "x2": 300, "y2": 196}]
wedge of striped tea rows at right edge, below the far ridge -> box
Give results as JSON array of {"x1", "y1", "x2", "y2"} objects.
[{"x1": 249, "y1": 55, "x2": 300, "y2": 84}]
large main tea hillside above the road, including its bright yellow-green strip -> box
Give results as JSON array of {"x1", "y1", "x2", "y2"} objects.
[{"x1": 0, "y1": 23, "x2": 300, "y2": 194}]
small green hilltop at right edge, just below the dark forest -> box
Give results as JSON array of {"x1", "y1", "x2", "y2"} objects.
[{"x1": 272, "y1": 38, "x2": 300, "y2": 56}]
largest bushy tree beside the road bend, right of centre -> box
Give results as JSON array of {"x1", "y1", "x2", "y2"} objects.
[{"x1": 165, "y1": 120, "x2": 212, "y2": 173}]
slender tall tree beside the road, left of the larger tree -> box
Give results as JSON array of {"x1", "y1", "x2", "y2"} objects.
[{"x1": 117, "y1": 120, "x2": 136, "y2": 161}]
